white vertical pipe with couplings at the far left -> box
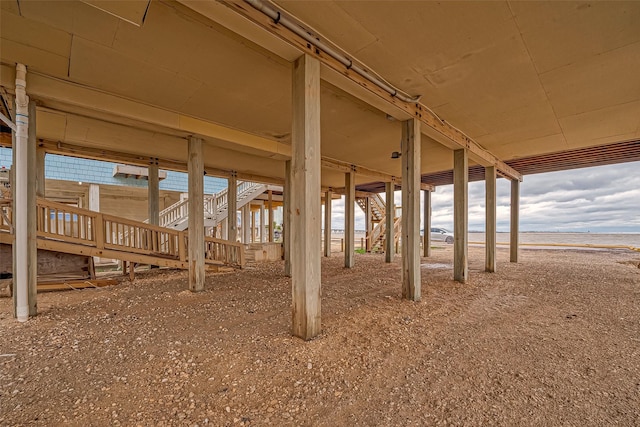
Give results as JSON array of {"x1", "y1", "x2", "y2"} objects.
[{"x1": 13, "y1": 64, "x2": 29, "y2": 322}]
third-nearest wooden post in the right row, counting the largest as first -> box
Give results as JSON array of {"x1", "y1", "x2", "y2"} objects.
[{"x1": 453, "y1": 149, "x2": 469, "y2": 283}]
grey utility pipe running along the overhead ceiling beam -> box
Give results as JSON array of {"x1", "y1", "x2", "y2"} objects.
[{"x1": 244, "y1": 0, "x2": 420, "y2": 103}]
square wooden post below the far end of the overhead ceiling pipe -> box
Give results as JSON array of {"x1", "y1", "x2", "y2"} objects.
[{"x1": 401, "y1": 119, "x2": 421, "y2": 301}]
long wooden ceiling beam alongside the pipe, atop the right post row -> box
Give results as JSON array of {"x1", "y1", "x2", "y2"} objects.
[{"x1": 219, "y1": 0, "x2": 522, "y2": 181}]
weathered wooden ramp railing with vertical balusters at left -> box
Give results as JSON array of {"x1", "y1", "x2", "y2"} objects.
[{"x1": 0, "y1": 198, "x2": 244, "y2": 267}]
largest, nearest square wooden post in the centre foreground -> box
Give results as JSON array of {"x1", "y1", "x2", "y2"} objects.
[{"x1": 290, "y1": 55, "x2": 322, "y2": 340}]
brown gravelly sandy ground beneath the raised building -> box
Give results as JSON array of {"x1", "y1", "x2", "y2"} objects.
[{"x1": 0, "y1": 247, "x2": 640, "y2": 426}]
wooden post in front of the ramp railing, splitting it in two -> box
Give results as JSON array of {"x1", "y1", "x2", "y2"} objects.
[{"x1": 188, "y1": 137, "x2": 205, "y2": 292}]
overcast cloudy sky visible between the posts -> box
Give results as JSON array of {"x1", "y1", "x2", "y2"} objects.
[{"x1": 332, "y1": 162, "x2": 640, "y2": 233}]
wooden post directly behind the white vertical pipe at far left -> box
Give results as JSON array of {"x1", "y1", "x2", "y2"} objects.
[{"x1": 26, "y1": 101, "x2": 37, "y2": 316}]
